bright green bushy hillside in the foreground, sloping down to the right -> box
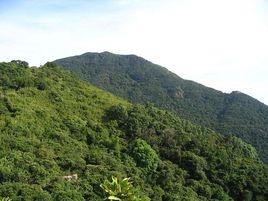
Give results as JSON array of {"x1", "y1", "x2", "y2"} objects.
[{"x1": 0, "y1": 61, "x2": 268, "y2": 201}]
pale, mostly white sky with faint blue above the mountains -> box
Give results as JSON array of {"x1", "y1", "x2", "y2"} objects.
[{"x1": 0, "y1": 0, "x2": 268, "y2": 105}]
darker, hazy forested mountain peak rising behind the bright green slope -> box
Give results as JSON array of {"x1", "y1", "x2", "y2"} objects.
[{"x1": 55, "y1": 52, "x2": 268, "y2": 162}]
